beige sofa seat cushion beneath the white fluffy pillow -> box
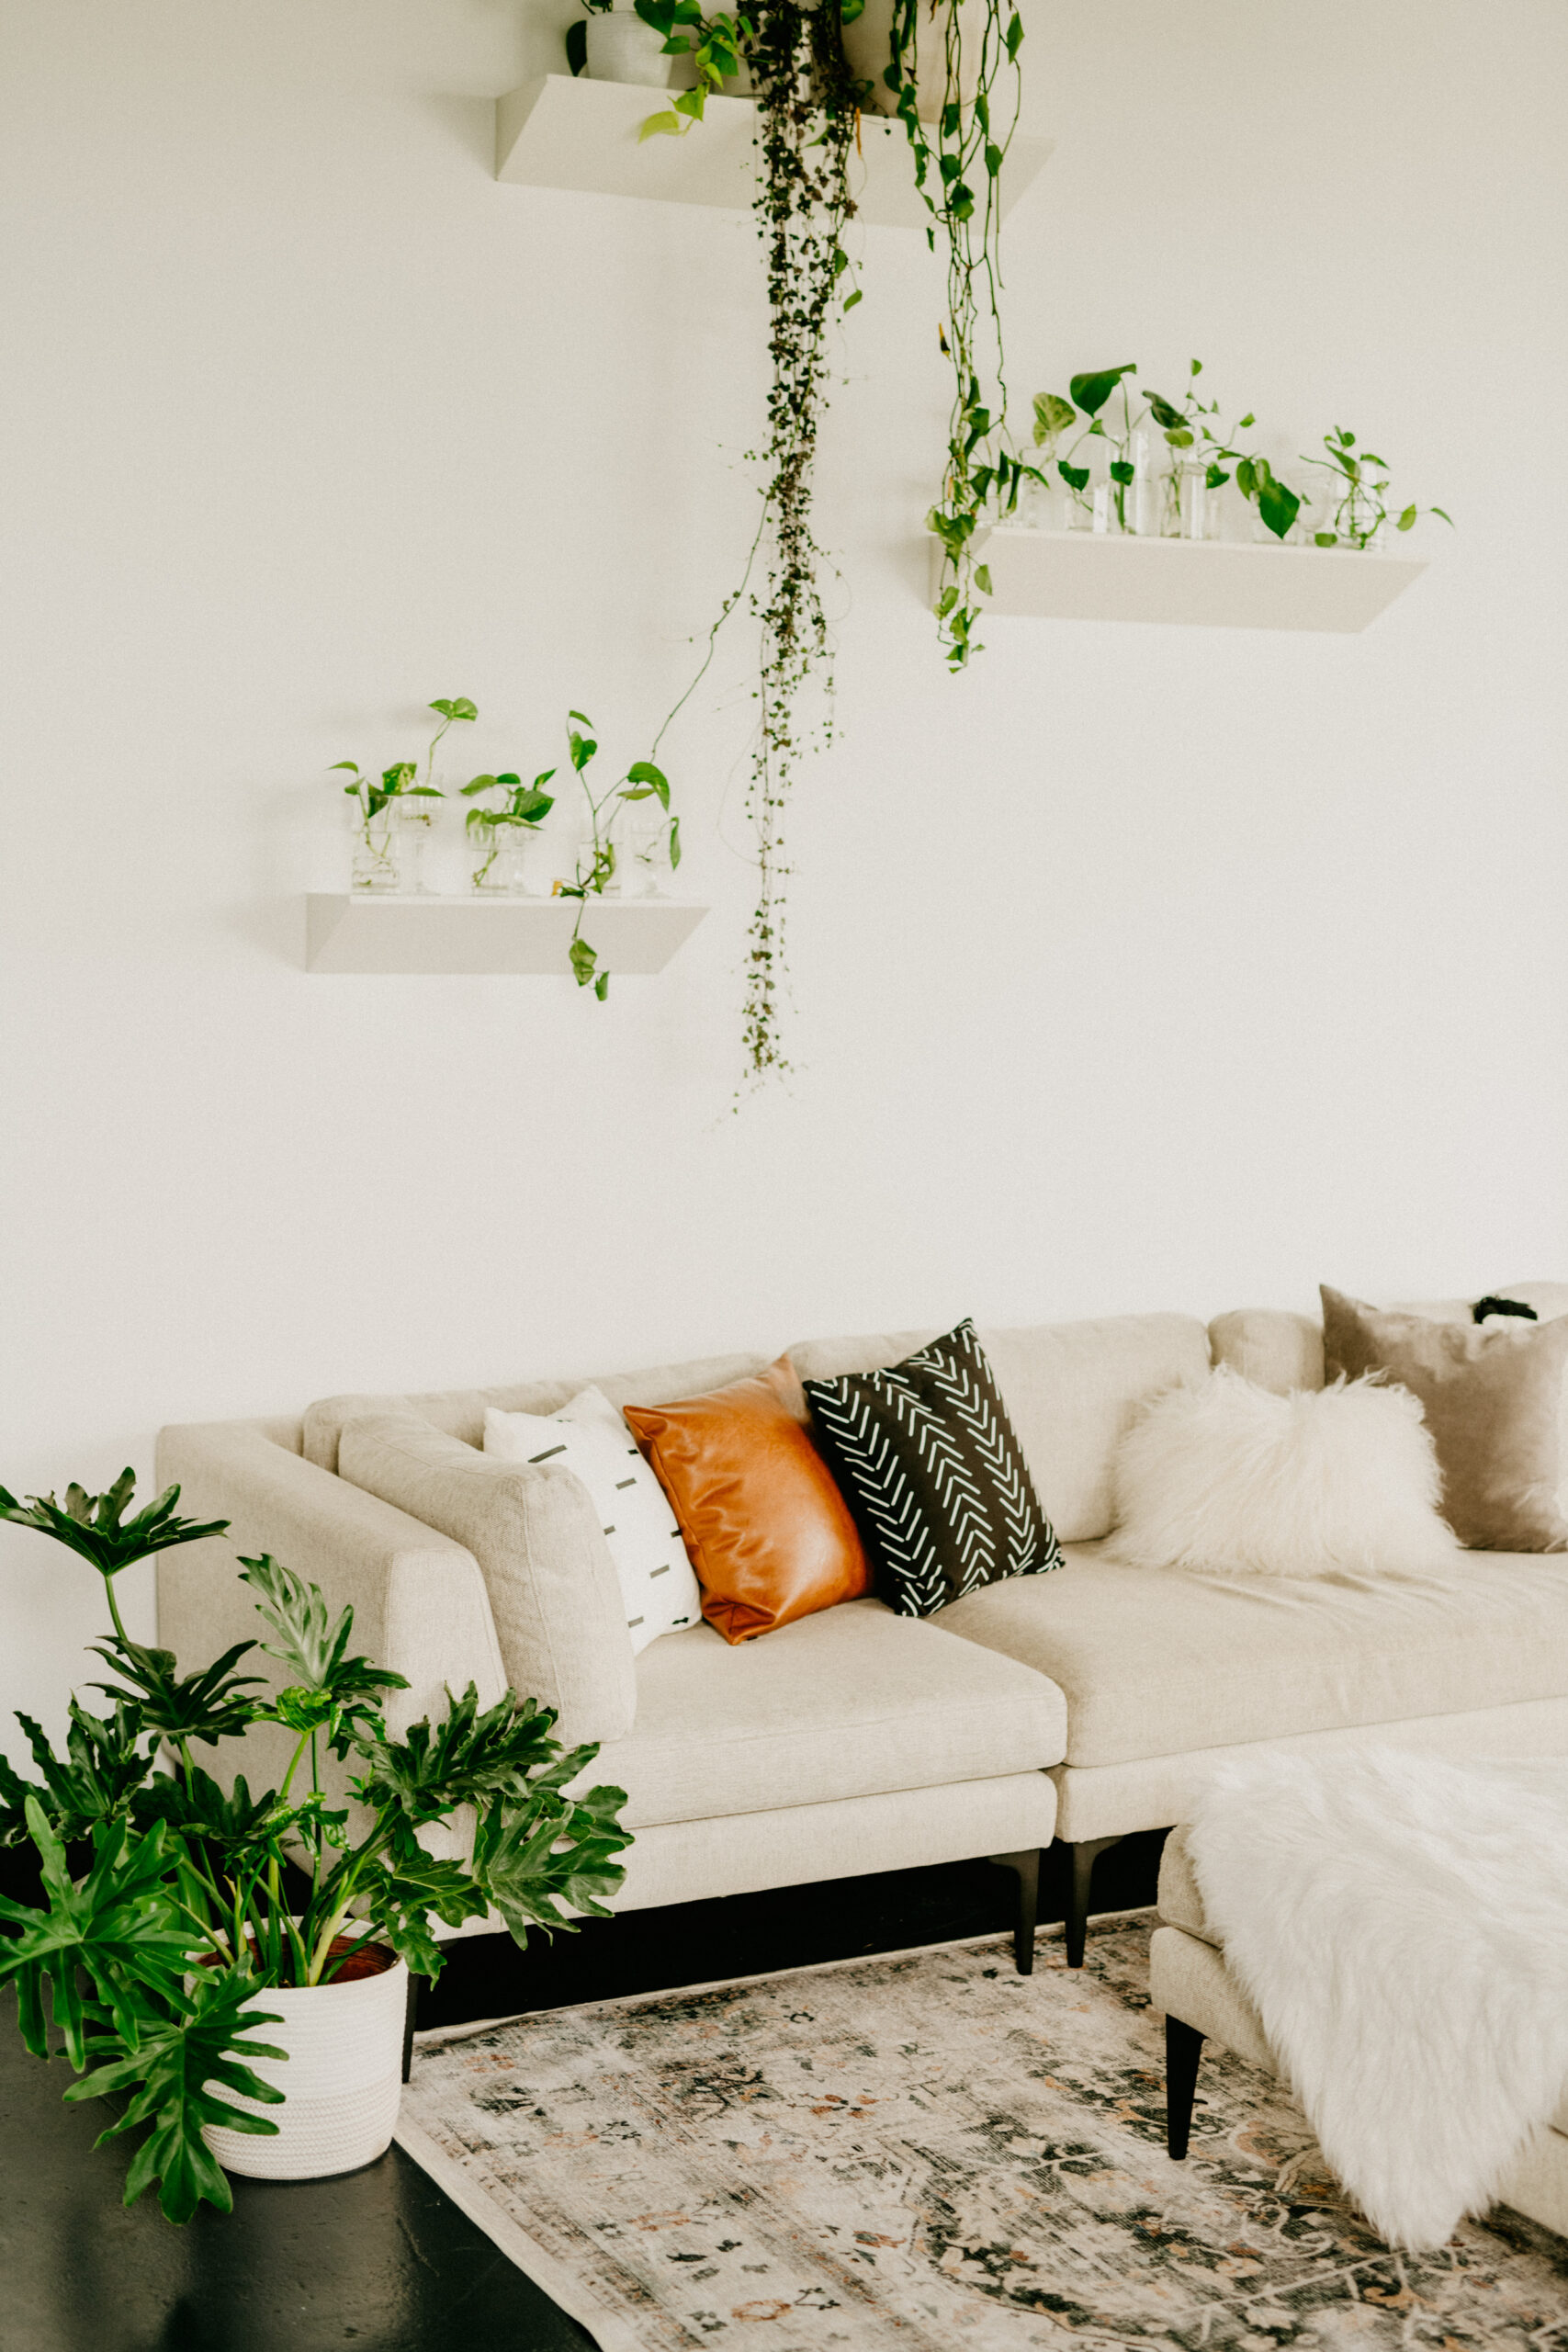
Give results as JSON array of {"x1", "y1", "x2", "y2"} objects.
[{"x1": 931, "y1": 1543, "x2": 1568, "y2": 1764}]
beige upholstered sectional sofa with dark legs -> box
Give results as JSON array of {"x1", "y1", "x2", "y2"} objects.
[{"x1": 157, "y1": 1284, "x2": 1568, "y2": 1964}]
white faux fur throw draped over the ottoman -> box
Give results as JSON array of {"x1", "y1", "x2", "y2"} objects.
[{"x1": 1187, "y1": 1747, "x2": 1568, "y2": 2248}]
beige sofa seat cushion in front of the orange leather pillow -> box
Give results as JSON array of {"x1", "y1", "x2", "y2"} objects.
[{"x1": 588, "y1": 1600, "x2": 1067, "y2": 1830}]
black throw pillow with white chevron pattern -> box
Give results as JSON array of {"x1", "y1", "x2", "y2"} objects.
[{"x1": 804, "y1": 1319, "x2": 1063, "y2": 1616}]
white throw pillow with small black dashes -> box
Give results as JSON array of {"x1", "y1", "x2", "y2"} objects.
[{"x1": 484, "y1": 1387, "x2": 703, "y2": 1656}]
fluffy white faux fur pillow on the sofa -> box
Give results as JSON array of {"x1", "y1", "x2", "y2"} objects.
[{"x1": 1112, "y1": 1364, "x2": 1464, "y2": 1576}]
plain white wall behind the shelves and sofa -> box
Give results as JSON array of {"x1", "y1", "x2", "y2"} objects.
[{"x1": 0, "y1": 0, "x2": 1568, "y2": 1746}]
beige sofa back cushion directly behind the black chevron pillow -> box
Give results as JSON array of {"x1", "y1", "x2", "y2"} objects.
[{"x1": 790, "y1": 1315, "x2": 1208, "y2": 1543}]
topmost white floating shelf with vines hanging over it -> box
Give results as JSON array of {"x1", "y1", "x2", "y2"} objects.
[{"x1": 496, "y1": 73, "x2": 1054, "y2": 228}]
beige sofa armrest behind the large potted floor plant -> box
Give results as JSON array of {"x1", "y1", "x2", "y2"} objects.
[{"x1": 157, "y1": 1420, "x2": 505, "y2": 1776}]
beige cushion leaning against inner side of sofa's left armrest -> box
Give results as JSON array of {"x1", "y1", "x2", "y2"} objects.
[{"x1": 336, "y1": 1408, "x2": 637, "y2": 1747}]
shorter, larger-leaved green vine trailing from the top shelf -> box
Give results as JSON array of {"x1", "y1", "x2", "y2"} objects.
[{"x1": 884, "y1": 0, "x2": 1032, "y2": 671}]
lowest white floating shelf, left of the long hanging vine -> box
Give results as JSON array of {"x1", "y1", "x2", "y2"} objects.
[{"x1": 306, "y1": 891, "x2": 707, "y2": 978}]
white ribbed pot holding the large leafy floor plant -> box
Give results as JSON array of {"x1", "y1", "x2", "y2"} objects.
[{"x1": 202, "y1": 1959, "x2": 409, "y2": 2180}]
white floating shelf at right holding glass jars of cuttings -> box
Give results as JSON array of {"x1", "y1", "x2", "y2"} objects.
[{"x1": 931, "y1": 529, "x2": 1427, "y2": 638}]
